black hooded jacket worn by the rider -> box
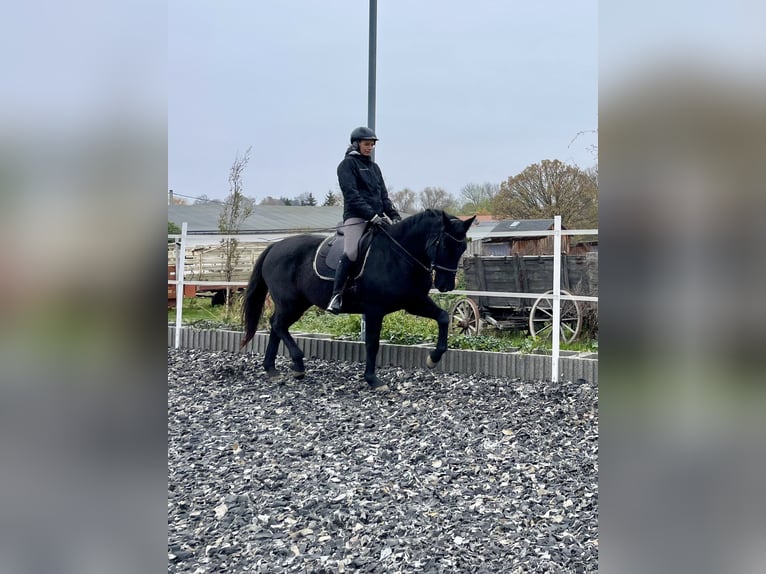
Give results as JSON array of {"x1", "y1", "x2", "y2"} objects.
[{"x1": 338, "y1": 150, "x2": 401, "y2": 220}]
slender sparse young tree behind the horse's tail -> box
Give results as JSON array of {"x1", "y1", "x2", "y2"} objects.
[{"x1": 218, "y1": 147, "x2": 253, "y2": 317}]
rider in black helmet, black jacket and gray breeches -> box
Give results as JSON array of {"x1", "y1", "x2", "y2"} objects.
[{"x1": 327, "y1": 127, "x2": 401, "y2": 315}]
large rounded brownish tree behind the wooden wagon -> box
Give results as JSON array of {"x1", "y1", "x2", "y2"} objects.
[{"x1": 494, "y1": 159, "x2": 598, "y2": 229}]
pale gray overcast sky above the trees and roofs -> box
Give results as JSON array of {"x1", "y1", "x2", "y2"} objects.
[{"x1": 168, "y1": 0, "x2": 598, "y2": 203}]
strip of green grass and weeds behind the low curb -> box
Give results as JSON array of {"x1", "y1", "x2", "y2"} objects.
[{"x1": 168, "y1": 295, "x2": 598, "y2": 353}]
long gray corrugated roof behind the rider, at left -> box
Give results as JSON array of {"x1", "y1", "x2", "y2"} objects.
[{"x1": 168, "y1": 203, "x2": 343, "y2": 232}]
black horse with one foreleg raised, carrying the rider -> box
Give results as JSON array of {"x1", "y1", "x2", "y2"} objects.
[{"x1": 242, "y1": 209, "x2": 474, "y2": 389}]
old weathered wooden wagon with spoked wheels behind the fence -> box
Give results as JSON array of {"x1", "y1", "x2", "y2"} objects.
[{"x1": 450, "y1": 254, "x2": 591, "y2": 342}]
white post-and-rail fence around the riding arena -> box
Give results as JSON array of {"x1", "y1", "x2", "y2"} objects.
[{"x1": 168, "y1": 215, "x2": 598, "y2": 382}]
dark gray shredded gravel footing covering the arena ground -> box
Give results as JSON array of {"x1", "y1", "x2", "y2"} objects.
[{"x1": 168, "y1": 349, "x2": 598, "y2": 574}]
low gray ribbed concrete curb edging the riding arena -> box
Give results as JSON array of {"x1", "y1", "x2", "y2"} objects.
[{"x1": 168, "y1": 325, "x2": 598, "y2": 385}]
